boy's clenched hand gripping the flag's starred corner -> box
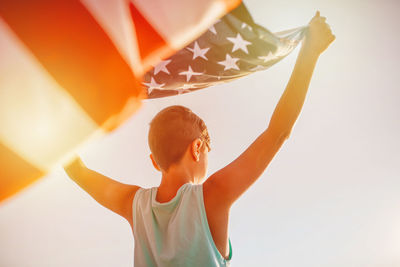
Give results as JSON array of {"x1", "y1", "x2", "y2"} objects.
[{"x1": 303, "y1": 11, "x2": 336, "y2": 55}]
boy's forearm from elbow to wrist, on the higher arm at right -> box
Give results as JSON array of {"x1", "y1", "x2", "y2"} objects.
[{"x1": 268, "y1": 42, "x2": 319, "y2": 137}]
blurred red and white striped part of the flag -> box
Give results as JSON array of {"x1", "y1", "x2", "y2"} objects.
[{"x1": 0, "y1": 0, "x2": 240, "y2": 201}]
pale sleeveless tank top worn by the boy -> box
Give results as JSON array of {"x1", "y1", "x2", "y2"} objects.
[{"x1": 132, "y1": 183, "x2": 232, "y2": 267}]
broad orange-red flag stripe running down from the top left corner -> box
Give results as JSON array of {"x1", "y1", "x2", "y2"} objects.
[{"x1": 0, "y1": 0, "x2": 144, "y2": 130}]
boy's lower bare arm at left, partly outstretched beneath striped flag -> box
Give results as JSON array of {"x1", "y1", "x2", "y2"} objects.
[{"x1": 63, "y1": 157, "x2": 140, "y2": 225}]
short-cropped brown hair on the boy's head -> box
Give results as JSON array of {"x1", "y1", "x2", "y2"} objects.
[{"x1": 148, "y1": 105, "x2": 210, "y2": 171}]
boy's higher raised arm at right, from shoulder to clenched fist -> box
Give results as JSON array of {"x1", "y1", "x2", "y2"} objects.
[{"x1": 203, "y1": 12, "x2": 335, "y2": 209}]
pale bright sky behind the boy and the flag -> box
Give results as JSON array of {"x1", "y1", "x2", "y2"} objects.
[{"x1": 0, "y1": 0, "x2": 400, "y2": 267}]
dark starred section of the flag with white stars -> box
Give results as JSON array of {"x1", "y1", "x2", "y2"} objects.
[{"x1": 142, "y1": 3, "x2": 307, "y2": 99}]
